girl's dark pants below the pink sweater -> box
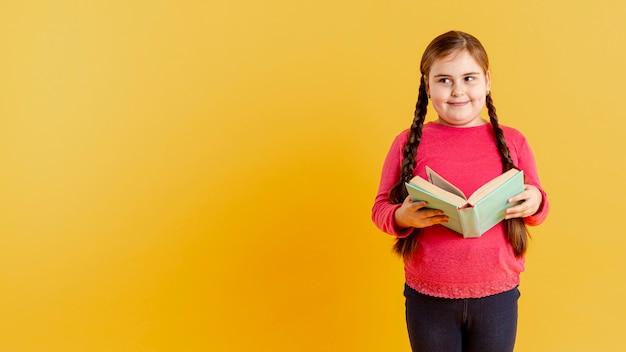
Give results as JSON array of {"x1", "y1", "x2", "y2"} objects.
[{"x1": 404, "y1": 284, "x2": 520, "y2": 352}]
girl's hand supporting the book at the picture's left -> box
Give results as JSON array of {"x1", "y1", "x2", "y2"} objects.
[{"x1": 394, "y1": 196, "x2": 448, "y2": 229}]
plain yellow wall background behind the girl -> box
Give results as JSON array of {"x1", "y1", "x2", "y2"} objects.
[{"x1": 0, "y1": 0, "x2": 626, "y2": 352}]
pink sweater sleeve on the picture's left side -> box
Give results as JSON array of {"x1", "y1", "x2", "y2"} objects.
[{"x1": 372, "y1": 131, "x2": 413, "y2": 237}]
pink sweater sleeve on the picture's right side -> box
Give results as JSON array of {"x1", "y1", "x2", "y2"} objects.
[{"x1": 510, "y1": 132, "x2": 550, "y2": 226}]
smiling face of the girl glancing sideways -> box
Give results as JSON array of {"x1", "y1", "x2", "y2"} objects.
[{"x1": 425, "y1": 50, "x2": 491, "y2": 127}]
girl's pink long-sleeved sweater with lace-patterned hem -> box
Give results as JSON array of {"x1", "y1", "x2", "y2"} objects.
[{"x1": 372, "y1": 122, "x2": 549, "y2": 298}]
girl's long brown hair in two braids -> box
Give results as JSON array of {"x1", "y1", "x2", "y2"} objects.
[{"x1": 389, "y1": 31, "x2": 528, "y2": 259}]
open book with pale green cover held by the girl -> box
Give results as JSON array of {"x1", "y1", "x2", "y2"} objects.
[{"x1": 406, "y1": 166, "x2": 524, "y2": 238}]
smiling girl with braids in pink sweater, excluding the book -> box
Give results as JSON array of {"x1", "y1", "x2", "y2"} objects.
[{"x1": 372, "y1": 31, "x2": 549, "y2": 352}]
